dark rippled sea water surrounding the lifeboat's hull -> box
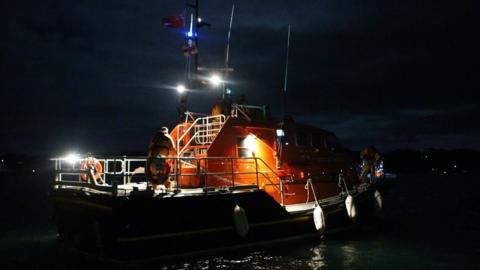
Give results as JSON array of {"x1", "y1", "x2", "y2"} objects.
[{"x1": 0, "y1": 174, "x2": 480, "y2": 270}]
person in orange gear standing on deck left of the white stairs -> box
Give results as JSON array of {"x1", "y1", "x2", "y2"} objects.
[{"x1": 147, "y1": 127, "x2": 176, "y2": 190}]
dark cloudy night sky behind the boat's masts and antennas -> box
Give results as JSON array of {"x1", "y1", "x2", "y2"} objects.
[{"x1": 0, "y1": 0, "x2": 480, "y2": 154}]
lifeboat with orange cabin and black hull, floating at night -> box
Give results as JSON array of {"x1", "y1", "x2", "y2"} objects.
[{"x1": 51, "y1": 104, "x2": 381, "y2": 258}]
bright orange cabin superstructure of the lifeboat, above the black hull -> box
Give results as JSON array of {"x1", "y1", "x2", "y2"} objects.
[{"x1": 167, "y1": 105, "x2": 358, "y2": 205}]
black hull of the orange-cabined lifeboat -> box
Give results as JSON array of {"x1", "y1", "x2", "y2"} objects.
[{"x1": 52, "y1": 189, "x2": 375, "y2": 259}]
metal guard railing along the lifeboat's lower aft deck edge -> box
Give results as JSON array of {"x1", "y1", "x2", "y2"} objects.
[{"x1": 52, "y1": 156, "x2": 284, "y2": 205}]
